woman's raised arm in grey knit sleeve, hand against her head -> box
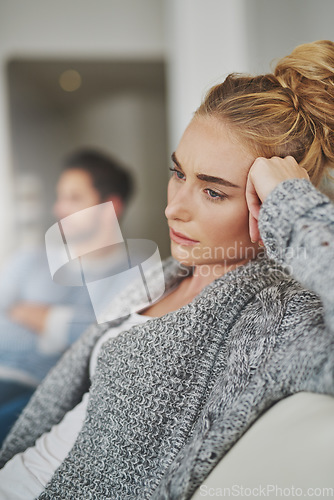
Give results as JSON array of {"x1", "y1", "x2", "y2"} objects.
[{"x1": 246, "y1": 157, "x2": 334, "y2": 331}]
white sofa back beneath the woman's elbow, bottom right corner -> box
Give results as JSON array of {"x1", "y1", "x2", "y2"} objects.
[{"x1": 192, "y1": 392, "x2": 334, "y2": 500}]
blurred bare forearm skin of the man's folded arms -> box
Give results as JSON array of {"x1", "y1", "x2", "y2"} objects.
[{"x1": 8, "y1": 302, "x2": 50, "y2": 334}]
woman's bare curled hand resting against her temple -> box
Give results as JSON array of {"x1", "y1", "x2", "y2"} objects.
[{"x1": 246, "y1": 156, "x2": 309, "y2": 244}]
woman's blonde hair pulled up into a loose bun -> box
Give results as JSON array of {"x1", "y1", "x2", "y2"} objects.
[{"x1": 195, "y1": 40, "x2": 334, "y2": 185}]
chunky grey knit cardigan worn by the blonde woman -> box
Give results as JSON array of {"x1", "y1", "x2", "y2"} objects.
[{"x1": 1, "y1": 180, "x2": 334, "y2": 500}]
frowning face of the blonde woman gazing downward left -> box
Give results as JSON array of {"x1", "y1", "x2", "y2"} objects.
[{"x1": 165, "y1": 117, "x2": 259, "y2": 277}]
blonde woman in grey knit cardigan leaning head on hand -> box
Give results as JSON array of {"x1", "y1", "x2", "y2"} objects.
[{"x1": 0, "y1": 41, "x2": 334, "y2": 499}]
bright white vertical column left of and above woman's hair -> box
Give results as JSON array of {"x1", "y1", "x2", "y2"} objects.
[{"x1": 165, "y1": 0, "x2": 248, "y2": 149}]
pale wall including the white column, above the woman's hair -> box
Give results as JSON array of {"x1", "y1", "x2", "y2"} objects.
[{"x1": 165, "y1": 0, "x2": 334, "y2": 149}]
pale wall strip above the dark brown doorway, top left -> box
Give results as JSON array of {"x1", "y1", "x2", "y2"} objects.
[{"x1": 0, "y1": 0, "x2": 164, "y2": 57}]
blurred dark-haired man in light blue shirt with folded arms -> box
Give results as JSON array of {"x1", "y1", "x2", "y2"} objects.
[{"x1": 0, "y1": 150, "x2": 133, "y2": 442}]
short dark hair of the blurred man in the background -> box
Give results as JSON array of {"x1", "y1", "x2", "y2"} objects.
[{"x1": 63, "y1": 149, "x2": 134, "y2": 203}]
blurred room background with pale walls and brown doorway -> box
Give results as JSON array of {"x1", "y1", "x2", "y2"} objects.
[{"x1": 0, "y1": 0, "x2": 334, "y2": 265}]
